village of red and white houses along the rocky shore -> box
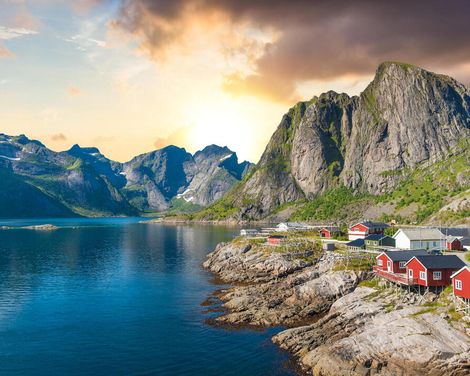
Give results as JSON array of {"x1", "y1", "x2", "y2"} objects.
[{"x1": 240, "y1": 220, "x2": 470, "y2": 315}]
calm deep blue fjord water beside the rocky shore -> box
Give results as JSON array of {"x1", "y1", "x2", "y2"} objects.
[{"x1": 0, "y1": 218, "x2": 294, "y2": 375}]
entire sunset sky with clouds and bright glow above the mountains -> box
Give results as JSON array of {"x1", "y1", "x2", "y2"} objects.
[{"x1": 0, "y1": 0, "x2": 470, "y2": 162}]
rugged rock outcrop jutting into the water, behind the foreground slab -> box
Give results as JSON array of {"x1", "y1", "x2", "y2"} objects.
[{"x1": 204, "y1": 243, "x2": 359, "y2": 326}]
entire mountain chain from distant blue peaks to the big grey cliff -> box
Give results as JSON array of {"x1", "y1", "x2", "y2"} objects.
[{"x1": 0, "y1": 62, "x2": 470, "y2": 223}]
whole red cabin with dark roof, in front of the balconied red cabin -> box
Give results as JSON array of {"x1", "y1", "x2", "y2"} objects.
[{"x1": 405, "y1": 255, "x2": 465, "y2": 287}]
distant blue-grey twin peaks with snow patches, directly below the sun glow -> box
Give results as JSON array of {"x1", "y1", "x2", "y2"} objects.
[{"x1": 121, "y1": 145, "x2": 251, "y2": 211}]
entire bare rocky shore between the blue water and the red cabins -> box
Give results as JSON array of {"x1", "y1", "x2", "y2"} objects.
[{"x1": 204, "y1": 240, "x2": 470, "y2": 376}]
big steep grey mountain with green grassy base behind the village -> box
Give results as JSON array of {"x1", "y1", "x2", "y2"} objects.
[{"x1": 196, "y1": 62, "x2": 470, "y2": 222}]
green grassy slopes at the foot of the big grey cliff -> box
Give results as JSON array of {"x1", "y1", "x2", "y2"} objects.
[{"x1": 190, "y1": 140, "x2": 470, "y2": 223}]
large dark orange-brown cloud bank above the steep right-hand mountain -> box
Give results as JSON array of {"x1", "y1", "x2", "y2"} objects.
[{"x1": 114, "y1": 0, "x2": 470, "y2": 100}]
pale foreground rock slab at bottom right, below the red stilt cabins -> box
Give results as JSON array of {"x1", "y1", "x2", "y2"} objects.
[{"x1": 273, "y1": 288, "x2": 470, "y2": 376}]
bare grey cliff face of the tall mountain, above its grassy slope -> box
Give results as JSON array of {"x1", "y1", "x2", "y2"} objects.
[{"x1": 223, "y1": 63, "x2": 470, "y2": 219}]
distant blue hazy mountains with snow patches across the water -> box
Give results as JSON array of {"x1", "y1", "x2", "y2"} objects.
[{"x1": 0, "y1": 134, "x2": 251, "y2": 218}]
